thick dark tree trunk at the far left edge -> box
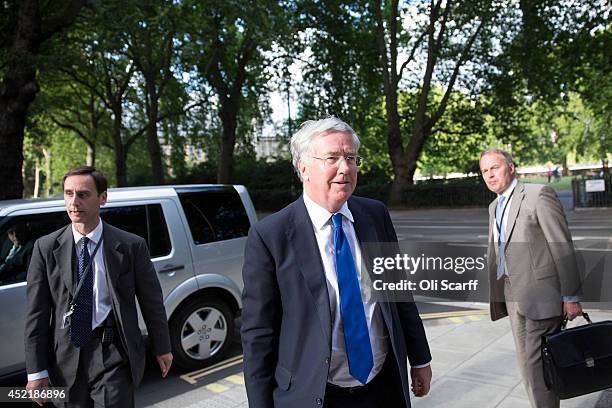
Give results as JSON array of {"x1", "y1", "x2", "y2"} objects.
[{"x1": 0, "y1": 0, "x2": 41, "y2": 200}]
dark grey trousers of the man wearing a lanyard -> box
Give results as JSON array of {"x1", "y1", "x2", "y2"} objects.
[{"x1": 64, "y1": 335, "x2": 134, "y2": 408}]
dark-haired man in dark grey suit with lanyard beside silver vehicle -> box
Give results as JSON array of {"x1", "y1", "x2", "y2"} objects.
[{"x1": 25, "y1": 167, "x2": 172, "y2": 407}]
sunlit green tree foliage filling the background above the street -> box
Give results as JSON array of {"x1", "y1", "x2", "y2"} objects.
[{"x1": 7, "y1": 0, "x2": 612, "y2": 198}]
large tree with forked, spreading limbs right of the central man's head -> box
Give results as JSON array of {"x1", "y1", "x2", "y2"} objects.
[{"x1": 371, "y1": 0, "x2": 495, "y2": 204}]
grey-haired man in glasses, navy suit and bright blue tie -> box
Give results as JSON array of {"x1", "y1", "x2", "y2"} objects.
[{"x1": 242, "y1": 117, "x2": 431, "y2": 408}]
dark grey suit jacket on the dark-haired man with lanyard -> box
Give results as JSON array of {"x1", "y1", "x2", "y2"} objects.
[{"x1": 25, "y1": 223, "x2": 170, "y2": 387}]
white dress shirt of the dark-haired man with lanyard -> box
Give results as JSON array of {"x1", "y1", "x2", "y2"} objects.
[{"x1": 28, "y1": 222, "x2": 111, "y2": 381}]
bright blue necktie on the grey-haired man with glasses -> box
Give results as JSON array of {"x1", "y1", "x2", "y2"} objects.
[{"x1": 332, "y1": 214, "x2": 374, "y2": 384}]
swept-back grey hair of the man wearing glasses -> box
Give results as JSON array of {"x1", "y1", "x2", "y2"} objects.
[{"x1": 290, "y1": 116, "x2": 361, "y2": 180}]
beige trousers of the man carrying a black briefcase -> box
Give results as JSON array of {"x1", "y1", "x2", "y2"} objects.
[{"x1": 504, "y1": 280, "x2": 562, "y2": 408}]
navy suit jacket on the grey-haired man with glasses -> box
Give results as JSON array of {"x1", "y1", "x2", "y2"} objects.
[{"x1": 242, "y1": 197, "x2": 431, "y2": 408}]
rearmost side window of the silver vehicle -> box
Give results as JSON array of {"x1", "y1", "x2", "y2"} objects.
[{"x1": 177, "y1": 186, "x2": 250, "y2": 245}]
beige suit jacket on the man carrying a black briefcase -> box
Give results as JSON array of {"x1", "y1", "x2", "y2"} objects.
[{"x1": 488, "y1": 182, "x2": 580, "y2": 320}]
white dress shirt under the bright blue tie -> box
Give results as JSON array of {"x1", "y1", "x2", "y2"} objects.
[{"x1": 304, "y1": 192, "x2": 389, "y2": 387}]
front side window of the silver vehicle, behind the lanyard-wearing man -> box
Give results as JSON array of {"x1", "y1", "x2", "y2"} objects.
[{"x1": 0, "y1": 210, "x2": 70, "y2": 285}]
